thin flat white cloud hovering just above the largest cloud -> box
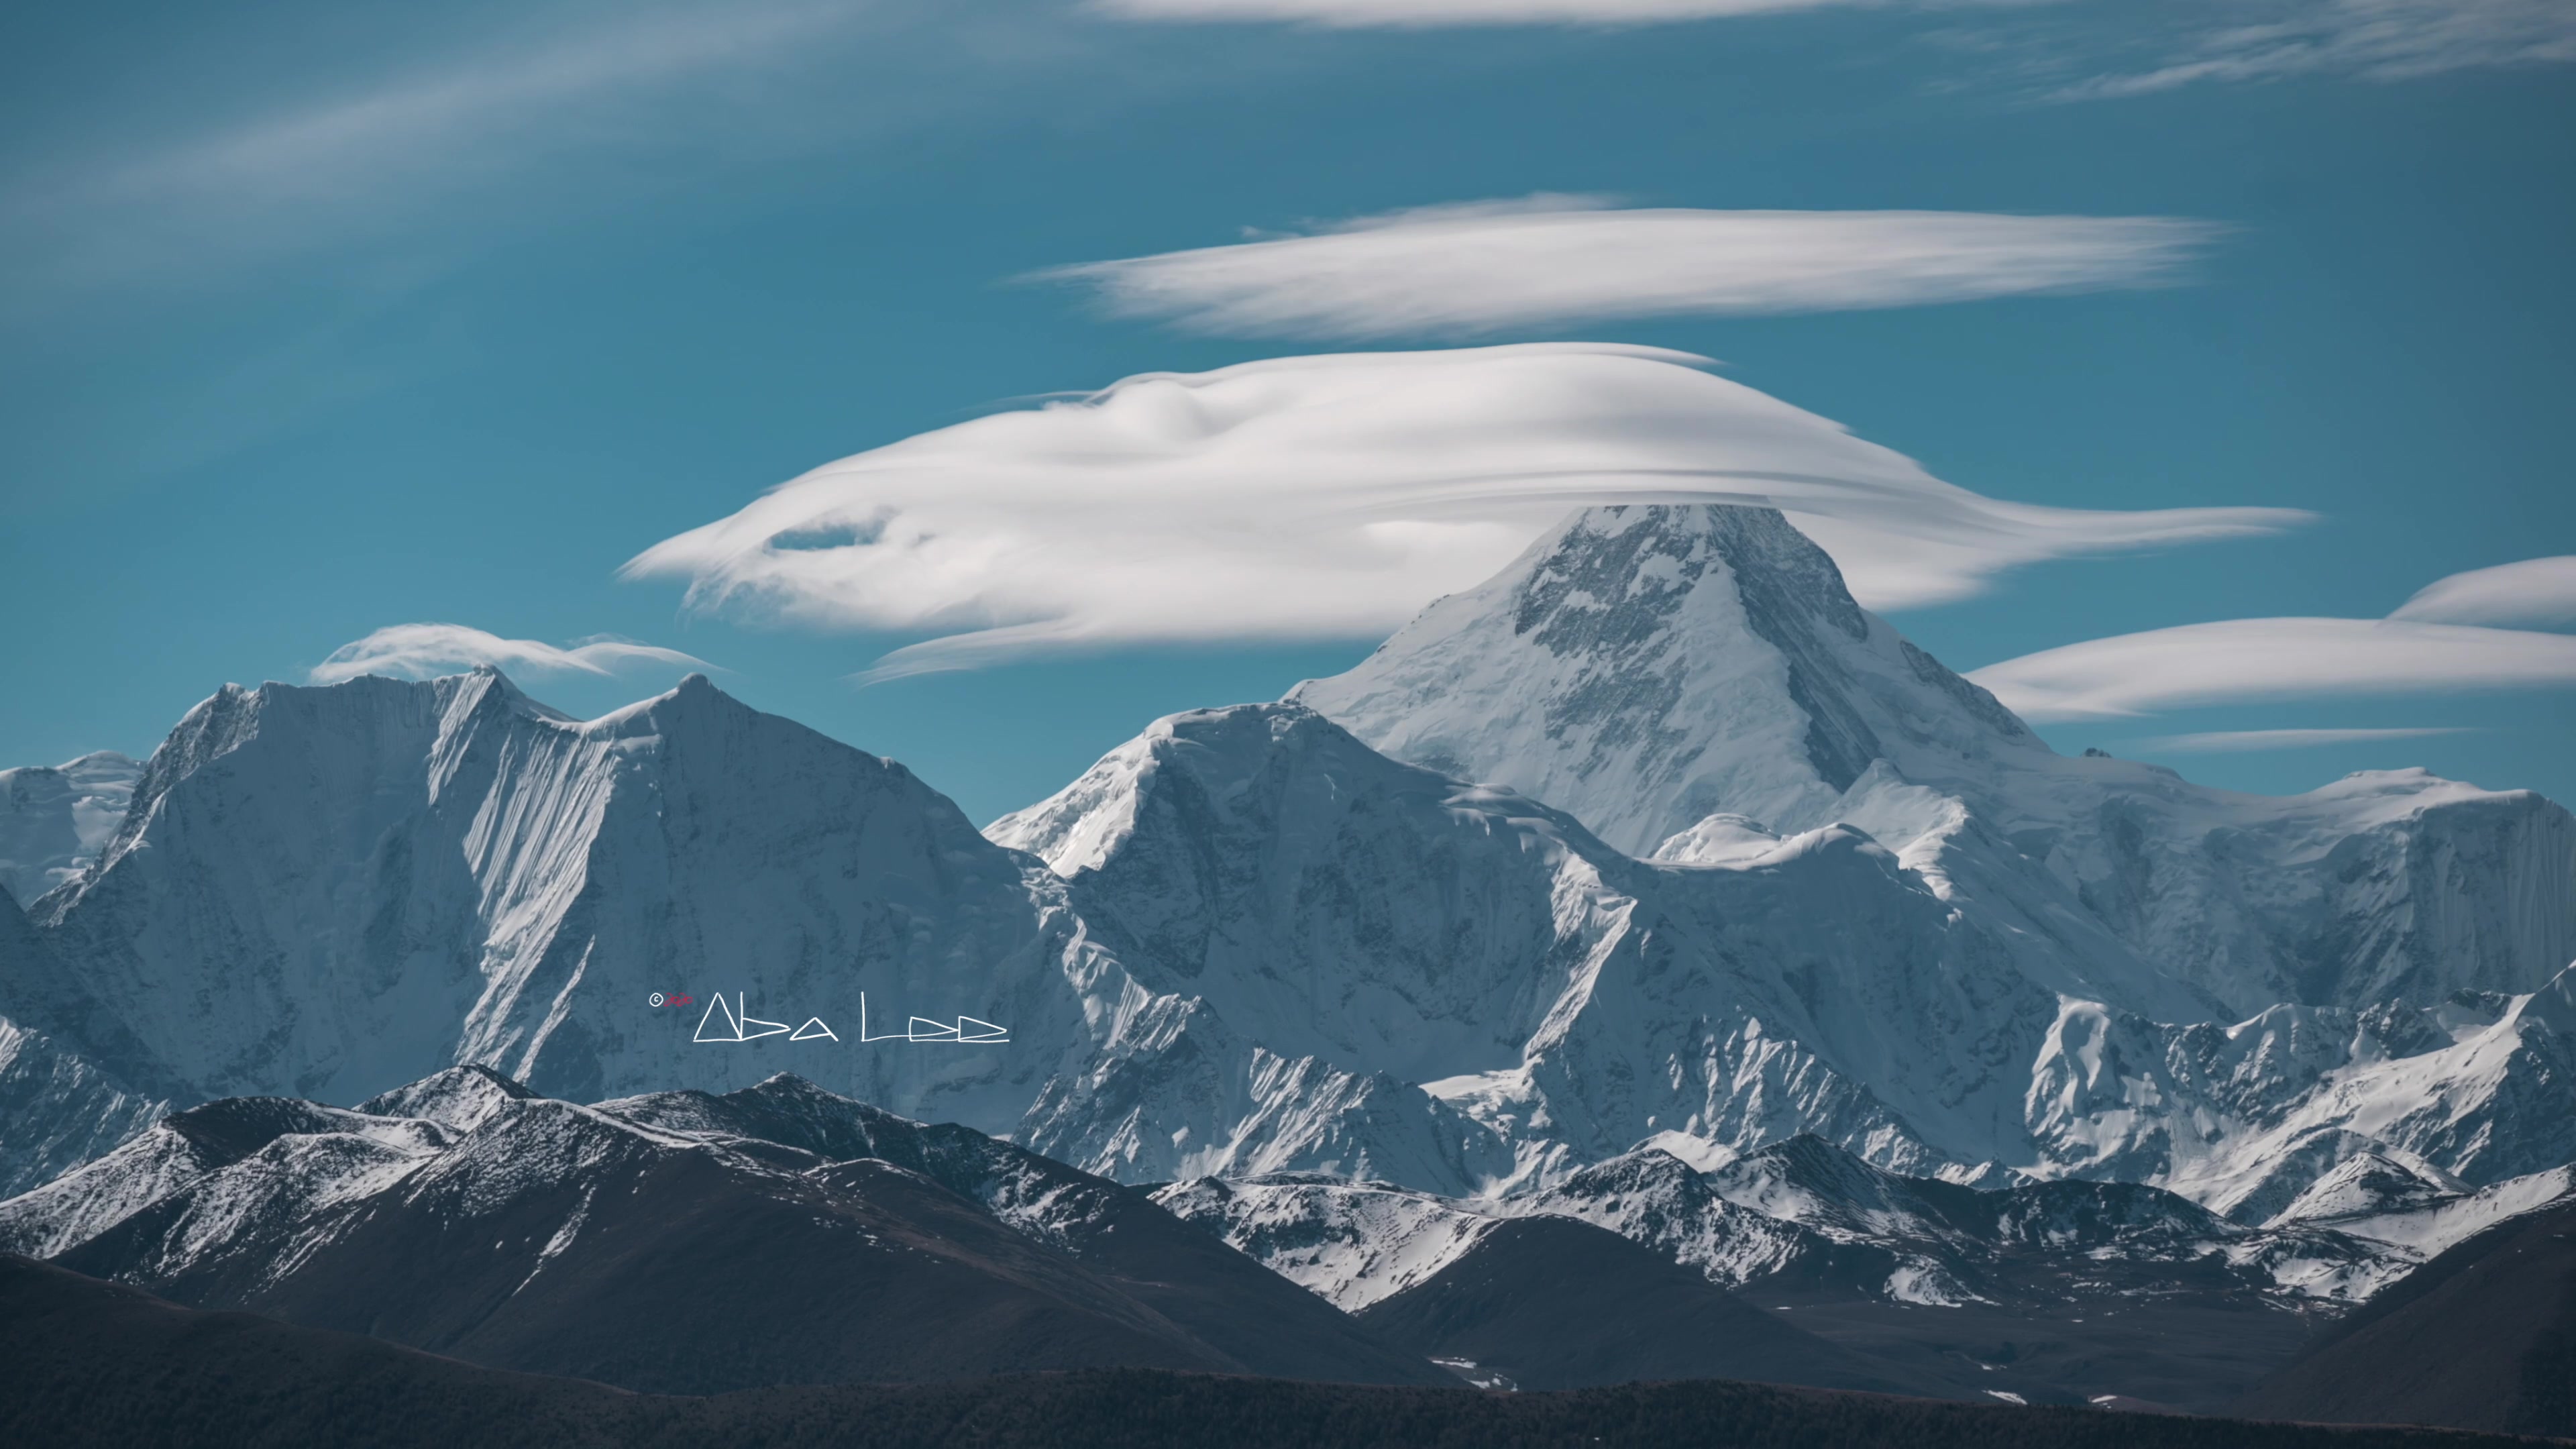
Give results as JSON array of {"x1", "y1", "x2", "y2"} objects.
[{"x1": 1038, "y1": 196, "x2": 2218, "y2": 337}]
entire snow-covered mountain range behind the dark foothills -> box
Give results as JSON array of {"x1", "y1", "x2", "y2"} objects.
[{"x1": 0, "y1": 505, "x2": 2576, "y2": 1212}]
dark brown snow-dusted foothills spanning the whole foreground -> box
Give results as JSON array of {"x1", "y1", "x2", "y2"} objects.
[{"x1": 15, "y1": 1067, "x2": 2576, "y2": 1410}]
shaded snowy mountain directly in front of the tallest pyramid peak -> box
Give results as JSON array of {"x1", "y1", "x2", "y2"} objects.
[{"x1": 989, "y1": 704, "x2": 2133, "y2": 1191}]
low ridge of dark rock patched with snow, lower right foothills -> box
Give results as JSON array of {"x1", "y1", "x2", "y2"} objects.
[{"x1": 1154, "y1": 1137, "x2": 2514, "y2": 1309}]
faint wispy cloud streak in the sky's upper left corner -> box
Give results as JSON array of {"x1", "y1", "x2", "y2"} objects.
[{"x1": 0, "y1": 0, "x2": 1030, "y2": 286}]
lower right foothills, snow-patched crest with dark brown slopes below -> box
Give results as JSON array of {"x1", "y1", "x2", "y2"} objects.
[{"x1": 1154, "y1": 1137, "x2": 2452, "y2": 1413}]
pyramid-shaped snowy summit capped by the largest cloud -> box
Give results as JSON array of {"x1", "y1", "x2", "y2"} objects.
[{"x1": 1291, "y1": 502, "x2": 2048, "y2": 853}]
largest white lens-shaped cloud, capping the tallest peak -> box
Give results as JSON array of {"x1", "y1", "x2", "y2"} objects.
[{"x1": 626, "y1": 343, "x2": 2306, "y2": 678}]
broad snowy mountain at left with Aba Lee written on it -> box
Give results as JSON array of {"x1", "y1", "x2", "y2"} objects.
[{"x1": 23, "y1": 670, "x2": 1118, "y2": 1129}]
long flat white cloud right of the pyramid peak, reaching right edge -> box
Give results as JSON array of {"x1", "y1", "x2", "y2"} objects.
[{"x1": 1968, "y1": 619, "x2": 2576, "y2": 722}]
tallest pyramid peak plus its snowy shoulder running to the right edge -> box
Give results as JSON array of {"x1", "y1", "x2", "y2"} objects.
[{"x1": 1291, "y1": 505, "x2": 2576, "y2": 1021}]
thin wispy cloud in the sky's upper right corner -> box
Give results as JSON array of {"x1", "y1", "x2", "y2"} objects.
[{"x1": 2066, "y1": 0, "x2": 2576, "y2": 98}]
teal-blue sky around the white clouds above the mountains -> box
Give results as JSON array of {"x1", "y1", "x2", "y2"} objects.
[{"x1": 0, "y1": 0, "x2": 2576, "y2": 820}]
